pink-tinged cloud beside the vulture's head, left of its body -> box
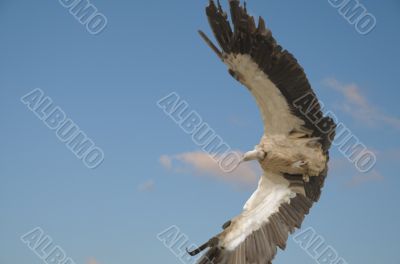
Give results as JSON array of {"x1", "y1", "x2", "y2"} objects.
[{"x1": 160, "y1": 152, "x2": 262, "y2": 188}]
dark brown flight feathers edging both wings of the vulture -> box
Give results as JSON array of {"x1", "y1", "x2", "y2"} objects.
[{"x1": 195, "y1": 0, "x2": 336, "y2": 264}]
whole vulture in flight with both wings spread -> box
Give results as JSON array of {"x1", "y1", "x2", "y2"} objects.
[{"x1": 188, "y1": 0, "x2": 336, "y2": 264}]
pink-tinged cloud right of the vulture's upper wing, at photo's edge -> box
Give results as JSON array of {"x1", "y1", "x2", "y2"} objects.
[{"x1": 324, "y1": 78, "x2": 400, "y2": 130}]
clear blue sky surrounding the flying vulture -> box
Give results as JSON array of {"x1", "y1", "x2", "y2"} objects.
[{"x1": 0, "y1": 0, "x2": 400, "y2": 264}]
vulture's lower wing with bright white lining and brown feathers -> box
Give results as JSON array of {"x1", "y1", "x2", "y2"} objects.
[{"x1": 199, "y1": 173, "x2": 312, "y2": 264}]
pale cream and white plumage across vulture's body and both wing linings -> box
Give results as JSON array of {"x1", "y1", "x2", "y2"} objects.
[{"x1": 216, "y1": 54, "x2": 326, "y2": 251}]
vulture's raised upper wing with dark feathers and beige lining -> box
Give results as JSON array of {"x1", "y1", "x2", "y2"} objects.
[{"x1": 200, "y1": 0, "x2": 335, "y2": 150}]
